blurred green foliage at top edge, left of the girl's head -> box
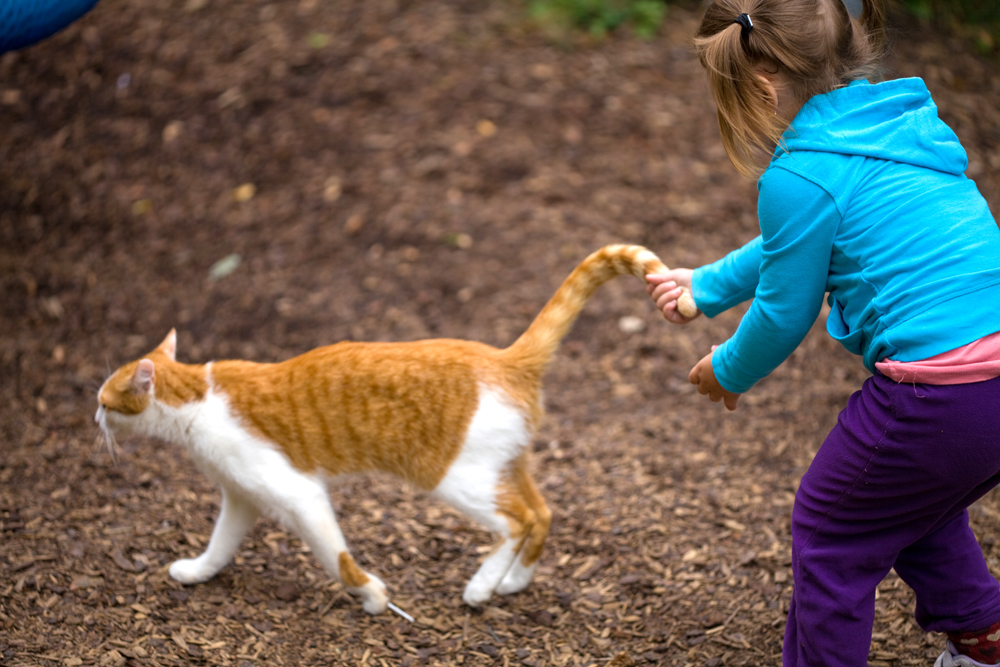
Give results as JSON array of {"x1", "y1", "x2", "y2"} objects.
[{"x1": 528, "y1": 0, "x2": 667, "y2": 39}]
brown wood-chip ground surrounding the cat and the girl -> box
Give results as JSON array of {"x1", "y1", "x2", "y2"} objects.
[{"x1": 0, "y1": 0, "x2": 1000, "y2": 667}]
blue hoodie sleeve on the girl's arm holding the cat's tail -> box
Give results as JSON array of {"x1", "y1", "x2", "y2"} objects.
[{"x1": 691, "y1": 236, "x2": 761, "y2": 317}]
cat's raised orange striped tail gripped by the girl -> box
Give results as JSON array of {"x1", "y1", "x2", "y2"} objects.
[{"x1": 504, "y1": 245, "x2": 697, "y2": 370}]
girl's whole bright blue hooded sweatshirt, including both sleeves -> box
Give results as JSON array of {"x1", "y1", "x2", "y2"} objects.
[{"x1": 693, "y1": 79, "x2": 1000, "y2": 393}]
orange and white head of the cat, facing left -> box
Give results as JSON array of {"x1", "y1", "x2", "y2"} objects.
[{"x1": 94, "y1": 329, "x2": 177, "y2": 438}]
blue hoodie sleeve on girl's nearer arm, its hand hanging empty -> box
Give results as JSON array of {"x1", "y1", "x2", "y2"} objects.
[{"x1": 712, "y1": 168, "x2": 842, "y2": 393}]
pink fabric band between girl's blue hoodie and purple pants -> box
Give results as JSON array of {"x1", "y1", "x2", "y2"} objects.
[{"x1": 875, "y1": 331, "x2": 1000, "y2": 384}]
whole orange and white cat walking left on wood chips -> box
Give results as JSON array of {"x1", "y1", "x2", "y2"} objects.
[{"x1": 95, "y1": 245, "x2": 693, "y2": 614}]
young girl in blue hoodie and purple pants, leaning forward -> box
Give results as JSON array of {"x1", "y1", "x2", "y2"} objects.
[{"x1": 649, "y1": 0, "x2": 1000, "y2": 667}]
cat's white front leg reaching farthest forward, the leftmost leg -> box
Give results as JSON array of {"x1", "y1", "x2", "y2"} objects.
[{"x1": 170, "y1": 488, "x2": 259, "y2": 584}]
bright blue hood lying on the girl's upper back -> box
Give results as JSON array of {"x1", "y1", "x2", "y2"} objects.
[{"x1": 774, "y1": 78, "x2": 969, "y2": 174}]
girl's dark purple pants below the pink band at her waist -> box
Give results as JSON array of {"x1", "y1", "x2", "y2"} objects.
[{"x1": 782, "y1": 374, "x2": 1000, "y2": 667}]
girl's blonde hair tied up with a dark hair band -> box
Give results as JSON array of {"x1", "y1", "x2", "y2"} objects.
[{"x1": 695, "y1": 0, "x2": 885, "y2": 177}]
